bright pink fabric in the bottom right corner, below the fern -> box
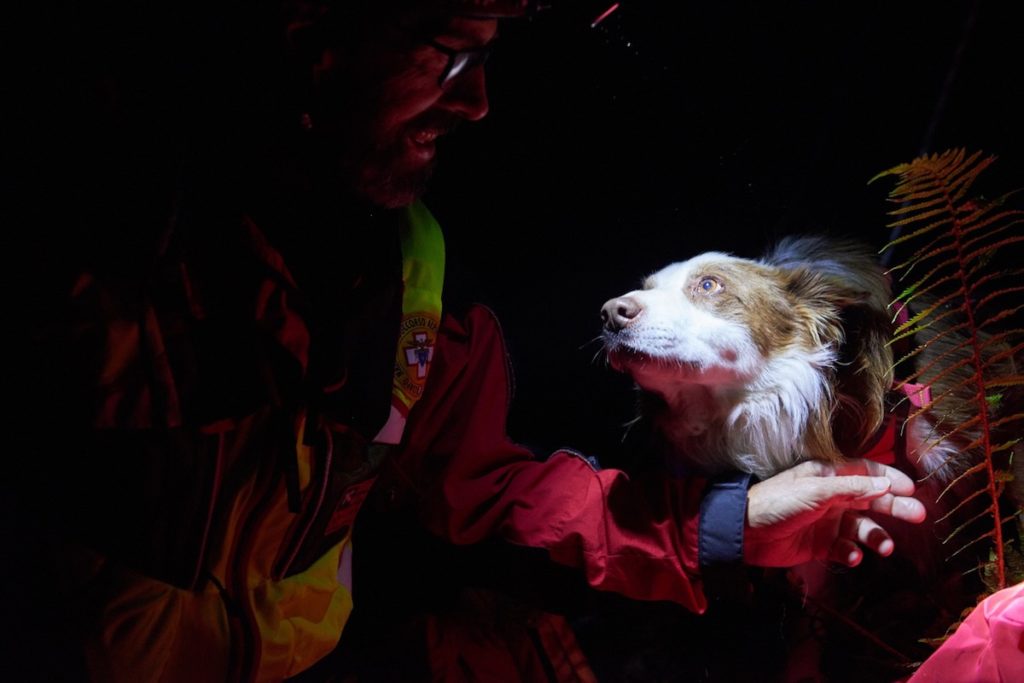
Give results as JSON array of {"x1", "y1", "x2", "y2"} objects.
[{"x1": 908, "y1": 583, "x2": 1024, "y2": 683}]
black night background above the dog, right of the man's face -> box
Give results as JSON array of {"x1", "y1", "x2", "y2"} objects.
[{"x1": 426, "y1": 0, "x2": 1024, "y2": 464}]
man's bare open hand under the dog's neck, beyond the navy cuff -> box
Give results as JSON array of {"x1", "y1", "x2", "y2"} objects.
[{"x1": 743, "y1": 460, "x2": 926, "y2": 566}]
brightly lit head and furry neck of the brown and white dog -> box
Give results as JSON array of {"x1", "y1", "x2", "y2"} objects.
[{"x1": 601, "y1": 237, "x2": 983, "y2": 478}]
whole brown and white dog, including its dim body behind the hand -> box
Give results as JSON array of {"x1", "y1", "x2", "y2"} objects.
[{"x1": 601, "y1": 237, "x2": 1024, "y2": 680}]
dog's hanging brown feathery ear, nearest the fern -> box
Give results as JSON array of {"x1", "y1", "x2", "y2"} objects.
[{"x1": 787, "y1": 263, "x2": 893, "y2": 456}]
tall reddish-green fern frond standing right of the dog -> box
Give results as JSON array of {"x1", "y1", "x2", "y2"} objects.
[{"x1": 870, "y1": 150, "x2": 1024, "y2": 588}]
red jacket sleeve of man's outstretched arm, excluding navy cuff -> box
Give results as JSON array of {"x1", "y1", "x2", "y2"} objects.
[{"x1": 395, "y1": 307, "x2": 706, "y2": 611}]
